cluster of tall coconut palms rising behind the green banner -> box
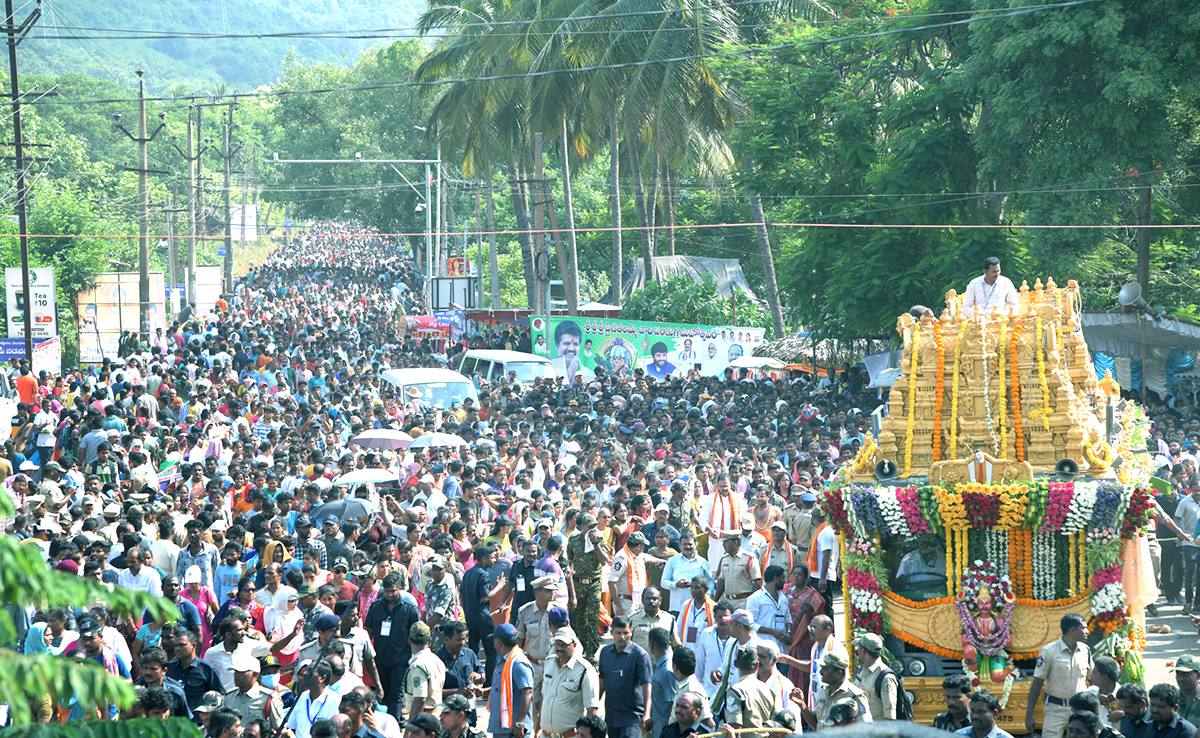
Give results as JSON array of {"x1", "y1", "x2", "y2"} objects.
[{"x1": 418, "y1": 0, "x2": 833, "y2": 314}]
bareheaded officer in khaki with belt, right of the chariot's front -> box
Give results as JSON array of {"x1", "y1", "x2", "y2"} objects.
[{"x1": 1025, "y1": 612, "x2": 1092, "y2": 738}]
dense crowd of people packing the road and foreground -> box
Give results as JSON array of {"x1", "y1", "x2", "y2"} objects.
[{"x1": 0, "y1": 224, "x2": 1200, "y2": 738}]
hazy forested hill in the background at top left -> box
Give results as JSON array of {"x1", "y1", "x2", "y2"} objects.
[{"x1": 18, "y1": 0, "x2": 425, "y2": 92}]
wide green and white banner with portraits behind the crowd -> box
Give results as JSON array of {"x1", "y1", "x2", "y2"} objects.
[{"x1": 530, "y1": 316, "x2": 764, "y2": 379}]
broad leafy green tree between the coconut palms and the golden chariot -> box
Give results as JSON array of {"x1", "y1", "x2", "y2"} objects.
[{"x1": 727, "y1": 2, "x2": 1012, "y2": 337}]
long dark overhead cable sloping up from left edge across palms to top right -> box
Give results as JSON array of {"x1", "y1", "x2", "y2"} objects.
[{"x1": 23, "y1": 0, "x2": 1100, "y2": 106}]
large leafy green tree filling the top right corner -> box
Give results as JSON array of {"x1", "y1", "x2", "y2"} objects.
[{"x1": 961, "y1": 0, "x2": 1200, "y2": 303}]
